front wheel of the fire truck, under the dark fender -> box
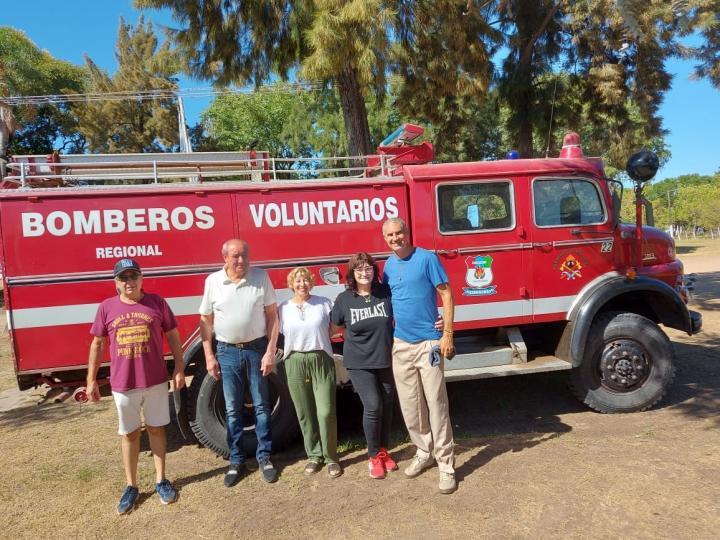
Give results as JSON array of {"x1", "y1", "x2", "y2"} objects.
[{"x1": 570, "y1": 311, "x2": 675, "y2": 413}]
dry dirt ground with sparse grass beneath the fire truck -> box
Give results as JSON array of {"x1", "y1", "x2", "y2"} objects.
[{"x1": 0, "y1": 246, "x2": 720, "y2": 540}]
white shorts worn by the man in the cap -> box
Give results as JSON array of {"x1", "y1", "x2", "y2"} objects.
[{"x1": 113, "y1": 382, "x2": 170, "y2": 435}]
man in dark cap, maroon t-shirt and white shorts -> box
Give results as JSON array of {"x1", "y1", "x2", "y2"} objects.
[{"x1": 87, "y1": 259, "x2": 185, "y2": 514}]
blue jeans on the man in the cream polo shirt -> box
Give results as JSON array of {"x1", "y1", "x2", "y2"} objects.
[{"x1": 216, "y1": 341, "x2": 272, "y2": 463}]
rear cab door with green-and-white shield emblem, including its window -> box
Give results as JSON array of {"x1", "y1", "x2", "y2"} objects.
[{"x1": 433, "y1": 179, "x2": 532, "y2": 329}]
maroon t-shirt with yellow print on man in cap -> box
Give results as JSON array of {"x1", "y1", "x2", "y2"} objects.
[{"x1": 90, "y1": 293, "x2": 177, "y2": 392}]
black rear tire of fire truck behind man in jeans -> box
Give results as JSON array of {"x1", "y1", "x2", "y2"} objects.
[{"x1": 190, "y1": 363, "x2": 300, "y2": 459}]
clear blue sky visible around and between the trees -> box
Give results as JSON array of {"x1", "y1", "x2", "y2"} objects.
[{"x1": 0, "y1": 0, "x2": 720, "y2": 180}]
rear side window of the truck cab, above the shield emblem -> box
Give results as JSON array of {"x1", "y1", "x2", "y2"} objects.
[{"x1": 437, "y1": 181, "x2": 515, "y2": 233}]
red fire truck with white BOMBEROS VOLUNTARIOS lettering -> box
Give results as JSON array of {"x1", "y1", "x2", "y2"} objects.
[{"x1": 0, "y1": 126, "x2": 702, "y2": 455}]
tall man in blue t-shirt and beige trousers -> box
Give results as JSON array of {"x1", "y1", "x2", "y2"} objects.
[{"x1": 383, "y1": 218, "x2": 457, "y2": 493}]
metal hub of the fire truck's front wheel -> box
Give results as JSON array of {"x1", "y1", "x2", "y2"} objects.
[{"x1": 600, "y1": 340, "x2": 650, "y2": 392}]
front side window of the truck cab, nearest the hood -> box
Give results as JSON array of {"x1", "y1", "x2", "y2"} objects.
[{"x1": 533, "y1": 178, "x2": 605, "y2": 227}]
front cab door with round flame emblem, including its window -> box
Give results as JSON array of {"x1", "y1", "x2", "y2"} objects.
[{"x1": 531, "y1": 177, "x2": 614, "y2": 322}]
